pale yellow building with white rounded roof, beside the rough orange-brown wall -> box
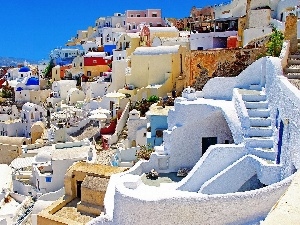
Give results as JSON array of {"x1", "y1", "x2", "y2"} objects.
[{"x1": 125, "y1": 45, "x2": 186, "y2": 97}]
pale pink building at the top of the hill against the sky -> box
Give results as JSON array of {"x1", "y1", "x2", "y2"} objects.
[{"x1": 125, "y1": 9, "x2": 165, "y2": 32}]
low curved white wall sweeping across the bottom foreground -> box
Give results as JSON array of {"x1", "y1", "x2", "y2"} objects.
[{"x1": 88, "y1": 174, "x2": 292, "y2": 225}]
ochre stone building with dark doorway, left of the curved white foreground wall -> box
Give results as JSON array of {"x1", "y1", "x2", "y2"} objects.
[{"x1": 37, "y1": 161, "x2": 126, "y2": 225}]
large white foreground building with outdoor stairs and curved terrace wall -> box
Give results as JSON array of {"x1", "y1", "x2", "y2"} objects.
[{"x1": 89, "y1": 46, "x2": 300, "y2": 225}]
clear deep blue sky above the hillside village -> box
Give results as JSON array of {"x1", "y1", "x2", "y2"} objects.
[{"x1": 0, "y1": 0, "x2": 225, "y2": 60}]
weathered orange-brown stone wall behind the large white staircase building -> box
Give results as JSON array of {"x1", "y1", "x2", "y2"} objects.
[{"x1": 185, "y1": 48, "x2": 265, "y2": 90}]
